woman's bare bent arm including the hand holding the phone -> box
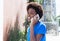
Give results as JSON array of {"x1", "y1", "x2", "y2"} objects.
[{"x1": 30, "y1": 17, "x2": 42, "y2": 41}]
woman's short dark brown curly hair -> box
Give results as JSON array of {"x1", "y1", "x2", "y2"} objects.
[{"x1": 27, "y1": 2, "x2": 43, "y2": 18}]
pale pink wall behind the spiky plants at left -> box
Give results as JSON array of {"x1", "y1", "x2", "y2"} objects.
[{"x1": 3, "y1": 0, "x2": 27, "y2": 41}]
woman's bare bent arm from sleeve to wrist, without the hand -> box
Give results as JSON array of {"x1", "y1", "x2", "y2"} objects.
[{"x1": 30, "y1": 25, "x2": 42, "y2": 41}]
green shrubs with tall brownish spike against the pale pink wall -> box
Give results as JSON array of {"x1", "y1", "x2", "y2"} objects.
[{"x1": 8, "y1": 15, "x2": 26, "y2": 41}]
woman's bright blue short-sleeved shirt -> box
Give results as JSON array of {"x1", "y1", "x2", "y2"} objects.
[{"x1": 27, "y1": 21, "x2": 46, "y2": 41}]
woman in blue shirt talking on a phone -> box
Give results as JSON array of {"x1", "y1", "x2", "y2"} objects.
[{"x1": 27, "y1": 2, "x2": 46, "y2": 41}]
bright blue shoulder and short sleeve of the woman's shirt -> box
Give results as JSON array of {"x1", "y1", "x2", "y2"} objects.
[{"x1": 34, "y1": 21, "x2": 46, "y2": 34}]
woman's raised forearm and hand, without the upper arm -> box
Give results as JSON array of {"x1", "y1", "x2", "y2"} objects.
[{"x1": 30, "y1": 18, "x2": 37, "y2": 41}]
